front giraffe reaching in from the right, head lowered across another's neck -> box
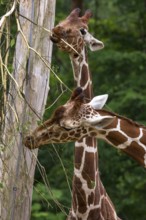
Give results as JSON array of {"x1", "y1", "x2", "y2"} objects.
[{"x1": 24, "y1": 88, "x2": 146, "y2": 167}]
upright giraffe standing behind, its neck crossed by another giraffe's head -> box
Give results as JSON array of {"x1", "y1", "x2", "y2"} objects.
[{"x1": 51, "y1": 8, "x2": 120, "y2": 220}]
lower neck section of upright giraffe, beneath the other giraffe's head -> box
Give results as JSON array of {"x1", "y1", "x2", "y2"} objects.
[{"x1": 68, "y1": 137, "x2": 119, "y2": 220}]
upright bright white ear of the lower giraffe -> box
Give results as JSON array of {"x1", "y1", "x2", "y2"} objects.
[{"x1": 89, "y1": 94, "x2": 108, "y2": 109}]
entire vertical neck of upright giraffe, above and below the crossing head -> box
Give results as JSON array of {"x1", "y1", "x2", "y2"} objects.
[{"x1": 68, "y1": 48, "x2": 118, "y2": 220}]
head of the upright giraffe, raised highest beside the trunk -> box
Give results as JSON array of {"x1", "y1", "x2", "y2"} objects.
[{"x1": 51, "y1": 8, "x2": 104, "y2": 57}]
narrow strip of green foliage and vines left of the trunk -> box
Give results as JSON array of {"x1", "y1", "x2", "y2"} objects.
[{"x1": 0, "y1": 0, "x2": 17, "y2": 122}]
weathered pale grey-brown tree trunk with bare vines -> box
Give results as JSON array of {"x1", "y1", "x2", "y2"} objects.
[{"x1": 0, "y1": 0, "x2": 56, "y2": 220}]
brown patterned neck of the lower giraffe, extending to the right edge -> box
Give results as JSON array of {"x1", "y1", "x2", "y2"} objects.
[{"x1": 97, "y1": 110, "x2": 146, "y2": 167}]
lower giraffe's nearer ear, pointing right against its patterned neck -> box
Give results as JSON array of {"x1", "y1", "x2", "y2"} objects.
[{"x1": 86, "y1": 115, "x2": 115, "y2": 129}]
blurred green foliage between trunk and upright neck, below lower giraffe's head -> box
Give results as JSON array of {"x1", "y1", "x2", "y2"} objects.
[{"x1": 32, "y1": 144, "x2": 73, "y2": 220}]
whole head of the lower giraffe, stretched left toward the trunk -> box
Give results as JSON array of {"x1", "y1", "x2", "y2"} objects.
[{"x1": 24, "y1": 87, "x2": 114, "y2": 149}]
